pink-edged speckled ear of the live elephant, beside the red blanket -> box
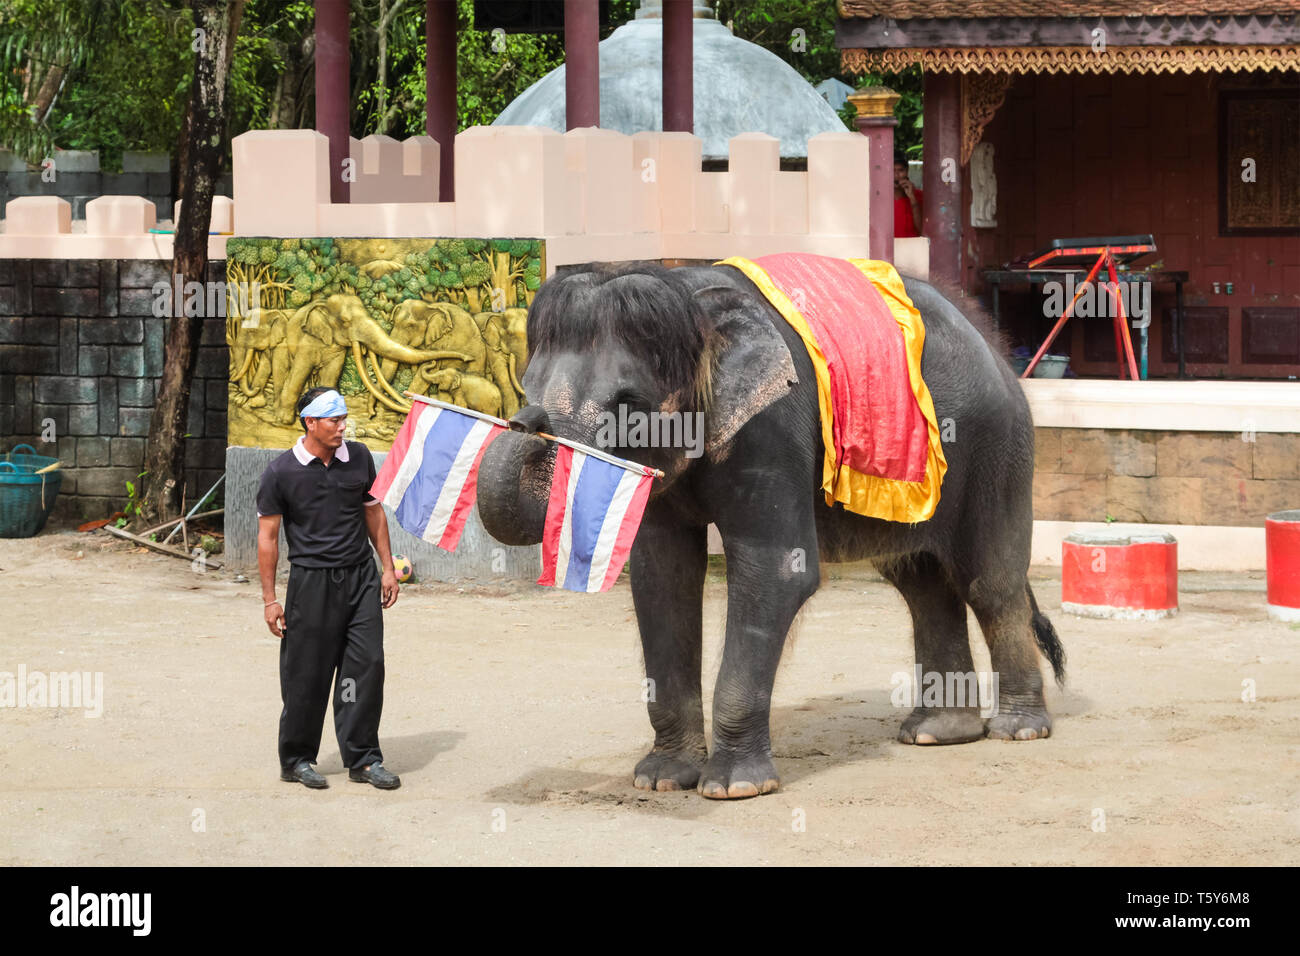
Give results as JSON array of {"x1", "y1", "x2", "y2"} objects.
[{"x1": 694, "y1": 286, "x2": 798, "y2": 462}]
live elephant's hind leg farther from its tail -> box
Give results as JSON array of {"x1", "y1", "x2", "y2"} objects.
[{"x1": 876, "y1": 554, "x2": 984, "y2": 744}]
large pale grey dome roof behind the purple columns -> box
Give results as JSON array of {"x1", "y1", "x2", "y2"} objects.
[{"x1": 493, "y1": 17, "x2": 845, "y2": 160}]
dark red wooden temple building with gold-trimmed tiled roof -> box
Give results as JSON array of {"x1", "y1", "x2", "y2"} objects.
[{"x1": 836, "y1": 0, "x2": 1300, "y2": 378}]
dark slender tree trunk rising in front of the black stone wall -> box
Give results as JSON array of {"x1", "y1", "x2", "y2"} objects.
[{"x1": 139, "y1": 0, "x2": 244, "y2": 525}]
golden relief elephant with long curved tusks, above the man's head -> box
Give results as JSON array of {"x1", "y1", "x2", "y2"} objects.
[{"x1": 276, "y1": 294, "x2": 467, "y2": 425}]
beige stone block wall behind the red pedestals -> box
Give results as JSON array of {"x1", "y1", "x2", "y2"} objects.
[{"x1": 1034, "y1": 429, "x2": 1300, "y2": 528}]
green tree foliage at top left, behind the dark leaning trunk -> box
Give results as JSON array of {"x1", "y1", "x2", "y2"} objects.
[{"x1": 0, "y1": 0, "x2": 316, "y2": 169}]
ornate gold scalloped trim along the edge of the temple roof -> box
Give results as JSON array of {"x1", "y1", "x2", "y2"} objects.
[{"x1": 840, "y1": 46, "x2": 1300, "y2": 73}]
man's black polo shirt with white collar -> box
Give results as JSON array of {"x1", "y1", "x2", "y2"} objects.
[{"x1": 257, "y1": 438, "x2": 380, "y2": 567}]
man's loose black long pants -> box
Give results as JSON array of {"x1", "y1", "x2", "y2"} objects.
[{"x1": 280, "y1": 558, "x2": 384, "y2": 770}]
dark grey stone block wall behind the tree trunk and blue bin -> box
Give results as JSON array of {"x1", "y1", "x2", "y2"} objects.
[{"x1": 0, "y1": 259, "x2": 229, "y2": 520}]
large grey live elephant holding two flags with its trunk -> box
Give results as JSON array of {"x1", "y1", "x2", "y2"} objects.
[{"x1": 477, "y1": 263, "x2": 1065, "y2": 799}]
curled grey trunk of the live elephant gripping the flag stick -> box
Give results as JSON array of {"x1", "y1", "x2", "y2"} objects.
[{"x1": 477, "y1": 406, "x2": 555, "y2": 545}]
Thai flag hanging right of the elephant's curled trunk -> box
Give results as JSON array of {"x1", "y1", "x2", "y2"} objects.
[{"x1": 537, "y1": 445, "x2": 653, "y2": 593}]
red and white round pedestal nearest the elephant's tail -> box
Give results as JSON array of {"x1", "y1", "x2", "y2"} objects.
[{"x1": 1061, "y1": 532, "x2": 1178, "y2": 620}]
